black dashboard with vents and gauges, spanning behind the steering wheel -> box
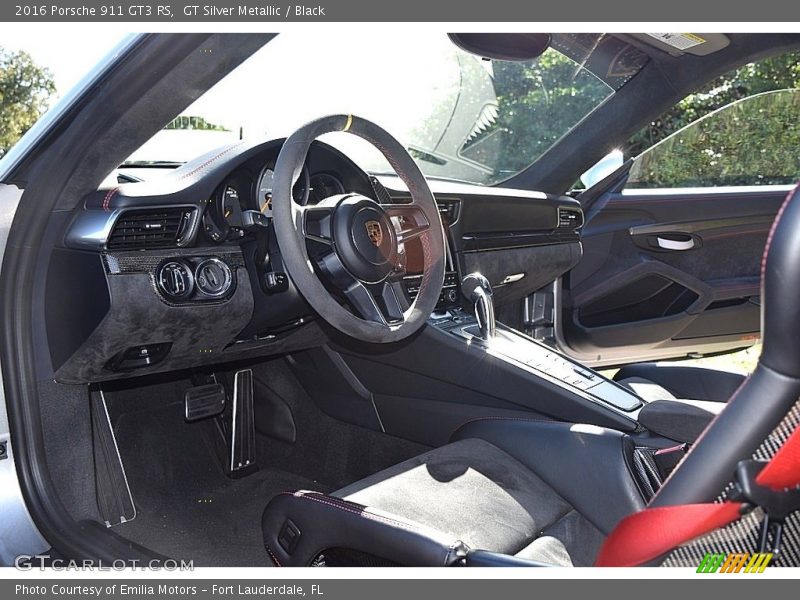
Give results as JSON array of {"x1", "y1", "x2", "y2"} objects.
[{"x1": 44, "y1": 140, "x2": 583, "y2": 383}]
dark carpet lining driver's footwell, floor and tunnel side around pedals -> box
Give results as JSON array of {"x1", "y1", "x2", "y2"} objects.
[{"x1": 106, "y1": 359, "x2": 428, "y2": 567}]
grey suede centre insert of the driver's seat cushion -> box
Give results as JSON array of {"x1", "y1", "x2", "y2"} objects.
[{"x1": 333, "y1": 438, "x2": 603, "y2": 566}]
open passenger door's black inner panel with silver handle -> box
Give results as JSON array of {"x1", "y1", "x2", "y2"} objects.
[{"x1": 556, "y1": 186, "x2": 791, "y2": 366}]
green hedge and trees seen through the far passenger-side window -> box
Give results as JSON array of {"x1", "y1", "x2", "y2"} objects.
[{"x1": 624, "y1": 52, "x2": 800, "y2": 188}]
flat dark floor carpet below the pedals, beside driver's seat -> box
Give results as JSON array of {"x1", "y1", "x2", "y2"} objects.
[{"x1": 113, "y1": 403, "x2": 333, "y2": 567}]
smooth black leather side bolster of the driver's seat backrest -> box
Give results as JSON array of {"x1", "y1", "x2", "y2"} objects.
[{"x1": 650, "y1": 187, "x2": 800, "y2": 507}]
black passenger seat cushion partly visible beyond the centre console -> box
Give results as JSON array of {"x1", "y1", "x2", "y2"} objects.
[{"x1": 614, "y1": 363, "x2": 745, "y2": 402}]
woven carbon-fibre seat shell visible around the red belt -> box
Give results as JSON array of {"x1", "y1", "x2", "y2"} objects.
[{"x1": 661, "y1": 401, "x2": 800, "y2": 568}]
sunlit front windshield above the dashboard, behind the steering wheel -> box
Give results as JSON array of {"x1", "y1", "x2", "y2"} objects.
[{"x1": 127, "y1": 30, "x2": 646, "y2": 185}]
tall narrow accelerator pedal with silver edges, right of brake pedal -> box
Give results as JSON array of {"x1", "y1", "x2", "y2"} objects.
[{"x1": 229, "y1": 369, "x2": 257, "y2": 477}]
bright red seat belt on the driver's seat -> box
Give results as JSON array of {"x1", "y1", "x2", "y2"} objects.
[{"x1": 595, "y1": 428, "x2": 800, "y2": 567}]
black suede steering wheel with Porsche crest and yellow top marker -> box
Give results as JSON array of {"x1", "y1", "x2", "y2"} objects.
[{"x1": 272, "y1": 115, "x2": 445, "y2": 343}]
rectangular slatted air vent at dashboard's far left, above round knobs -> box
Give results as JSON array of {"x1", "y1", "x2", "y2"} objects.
[{"x1": 106, "y1": 207, "x2": 196, "y2": 250}]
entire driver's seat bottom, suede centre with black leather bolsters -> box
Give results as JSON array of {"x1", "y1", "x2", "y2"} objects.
[{"x1": 262, "y1": 417, "x2": 644, "y2": 566}]
